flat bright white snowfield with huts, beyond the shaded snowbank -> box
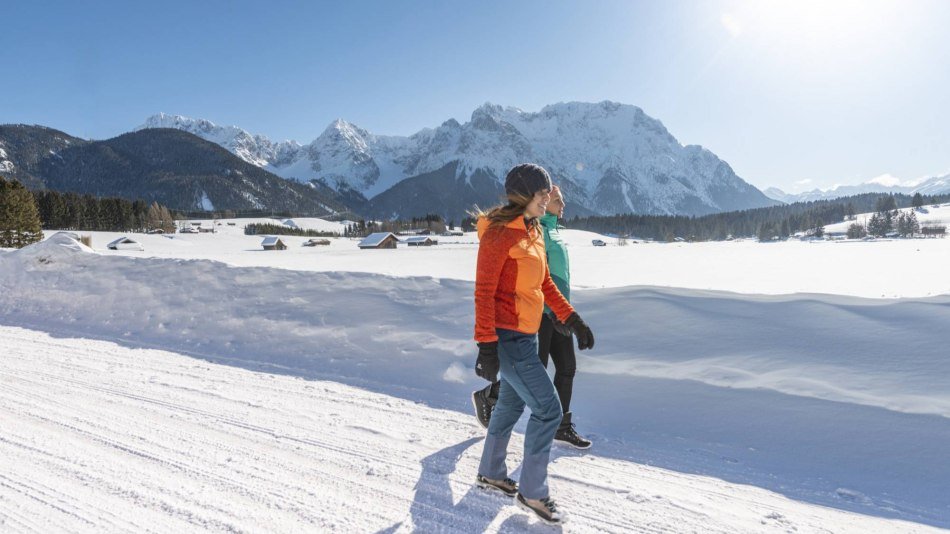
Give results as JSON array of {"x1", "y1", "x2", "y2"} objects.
[{"x1": 76, "y1": 209, "x2": 950, "y2": 298}]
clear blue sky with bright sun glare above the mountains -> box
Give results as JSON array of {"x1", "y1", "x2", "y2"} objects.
[{"x1": 0, "y1": 0, "x2": 950, "y2": 191}]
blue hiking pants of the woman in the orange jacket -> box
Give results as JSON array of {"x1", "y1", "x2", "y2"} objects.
[{"x1": 478, "y1": 328, "x2": 562, "y2": 499}]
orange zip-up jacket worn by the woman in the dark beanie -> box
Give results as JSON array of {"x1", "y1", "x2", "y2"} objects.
[{"x1": 475, "y1": 217, "x2": 574, "y2": 343}]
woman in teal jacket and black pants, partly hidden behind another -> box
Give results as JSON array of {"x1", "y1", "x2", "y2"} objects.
[{"x1": 472, "y1": 186, "x2": 591, "y2": 449}]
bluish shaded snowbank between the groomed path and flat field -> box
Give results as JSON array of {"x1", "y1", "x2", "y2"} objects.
[{"x1": 0, "y1": 236, "x2": 950, "y2": 528}]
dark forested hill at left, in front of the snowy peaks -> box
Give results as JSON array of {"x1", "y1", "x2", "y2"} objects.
[{"x1": 0, "y1": 125, "x2": 345, "y2": 215}]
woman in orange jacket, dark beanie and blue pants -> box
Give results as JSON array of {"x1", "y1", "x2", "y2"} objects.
[{"x1": 475, "y1": 163, "x2": 594, "y2": 523}]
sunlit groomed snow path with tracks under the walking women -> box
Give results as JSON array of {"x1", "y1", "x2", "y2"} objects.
[{"x1": 0, "y1": 326, "x2": 938, "y2": 533}]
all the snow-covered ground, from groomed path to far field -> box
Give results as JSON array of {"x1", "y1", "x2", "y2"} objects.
[{"x1": 0, "y1": 208, "x2": 950, "y2": 532}]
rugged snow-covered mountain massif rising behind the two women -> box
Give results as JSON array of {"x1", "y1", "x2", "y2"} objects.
[{"x1": 141, "y1": 101, "x2": 774, "y2": 220}]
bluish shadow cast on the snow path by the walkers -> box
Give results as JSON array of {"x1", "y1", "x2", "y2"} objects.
[{"x1": 377, "y1": 437, "x2": 561, "y2": 534}]
